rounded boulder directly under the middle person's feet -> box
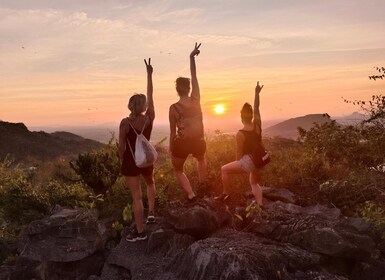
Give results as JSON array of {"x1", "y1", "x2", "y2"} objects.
[{"x1": 165, "y1": 199, "x2": 232, "y2": 239}]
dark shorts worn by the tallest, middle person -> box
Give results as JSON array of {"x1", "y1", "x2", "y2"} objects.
[{"x1": 172, "y1": 138, "x2": 206, "y2": 160}]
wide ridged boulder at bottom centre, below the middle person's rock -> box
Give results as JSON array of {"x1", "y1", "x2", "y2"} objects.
[{"x1": 169, "y1": 229, "x2": 344, "y2": 280}]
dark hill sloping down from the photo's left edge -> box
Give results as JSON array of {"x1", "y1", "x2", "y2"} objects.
[{"x1": 0, "y1": 121, "x2": 103, "y2": 162}]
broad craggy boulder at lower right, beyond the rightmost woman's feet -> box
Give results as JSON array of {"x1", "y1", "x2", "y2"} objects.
[{"x1": 251, "y1": 201, "x2": 376, "y2": 260}]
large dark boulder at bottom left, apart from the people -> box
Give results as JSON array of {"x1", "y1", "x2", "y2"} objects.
[{"x1": 14, "y1": 207, "x2": 107, "y2": 279}]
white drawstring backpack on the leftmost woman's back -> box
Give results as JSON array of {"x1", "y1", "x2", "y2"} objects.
[{"x1": 127, "y1": 118, "x2": 158, "y2": 168}]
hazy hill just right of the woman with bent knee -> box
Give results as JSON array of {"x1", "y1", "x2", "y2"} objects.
[{"x1": 263, "y1": 114, "x2": 331, "y2": 139}]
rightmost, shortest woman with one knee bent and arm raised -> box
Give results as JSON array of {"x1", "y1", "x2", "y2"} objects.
[{"x1": 215, "y1": 82, "x2": 263, "y2": 206}]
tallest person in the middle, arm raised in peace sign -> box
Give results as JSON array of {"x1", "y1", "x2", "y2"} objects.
[{"x1": 169, "y1": 43, "x2": 206, "y2": 202}]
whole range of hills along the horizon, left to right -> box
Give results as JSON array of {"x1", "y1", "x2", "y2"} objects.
[{"x1": 0, "y1": 113, "x2": 364, "y2": 162}]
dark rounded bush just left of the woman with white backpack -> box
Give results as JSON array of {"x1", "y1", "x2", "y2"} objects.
[{"x1": 71, "y1": 139, "x2": 120, "y2": 194}]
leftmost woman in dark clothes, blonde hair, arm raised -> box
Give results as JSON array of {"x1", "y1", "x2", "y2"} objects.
[{"x1": 119, "y1": 58, "x2": 155, "y2": 242}]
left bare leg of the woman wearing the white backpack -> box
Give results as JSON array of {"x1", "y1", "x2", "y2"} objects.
[{"x1": 124, "y1": 176, "x2": 143, "y2": 233}]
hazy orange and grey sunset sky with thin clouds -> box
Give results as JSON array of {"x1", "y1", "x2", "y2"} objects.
[{"x1": 0, "y1": 0, "x2": 385, "y2": 126}]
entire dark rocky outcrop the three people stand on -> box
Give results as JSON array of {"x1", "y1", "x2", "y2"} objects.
[{"x1": 0, "y1": 189, "x2": 385, "y2": 280}]
